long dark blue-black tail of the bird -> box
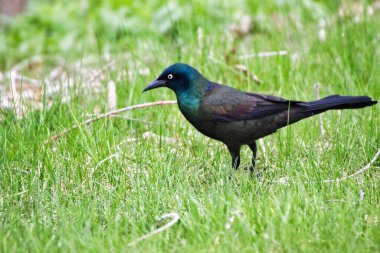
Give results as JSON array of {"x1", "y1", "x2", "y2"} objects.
[{"x1": 299, "y1": 95, "x2": 377, "y2": 115}]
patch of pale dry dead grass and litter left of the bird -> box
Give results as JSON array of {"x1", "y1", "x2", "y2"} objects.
[{"x1": 0, "y1": 53, "x2": 150, "y2": 119}]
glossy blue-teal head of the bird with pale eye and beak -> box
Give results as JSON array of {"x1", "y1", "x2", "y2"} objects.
[{"x1": 144, "y1": 63, "x2": 204, "y2": 93}]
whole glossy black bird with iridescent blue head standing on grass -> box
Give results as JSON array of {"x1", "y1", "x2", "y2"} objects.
[{"x1": 144, "y1": 63, "x2": 377, "y2": 171}]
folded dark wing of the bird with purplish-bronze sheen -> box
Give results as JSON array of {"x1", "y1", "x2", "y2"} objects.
[{"x1": 201, "y1": 84, "x2": 298, "y2": 122}]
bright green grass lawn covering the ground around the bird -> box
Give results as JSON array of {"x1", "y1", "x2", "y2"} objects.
[{"x1": 0, "y1": 1, "x2": 380, "y2": 252}]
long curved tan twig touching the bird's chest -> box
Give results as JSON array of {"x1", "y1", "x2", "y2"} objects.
[{"x1": 43, "y1": 100, "x2": 177, "y2": 145}]
